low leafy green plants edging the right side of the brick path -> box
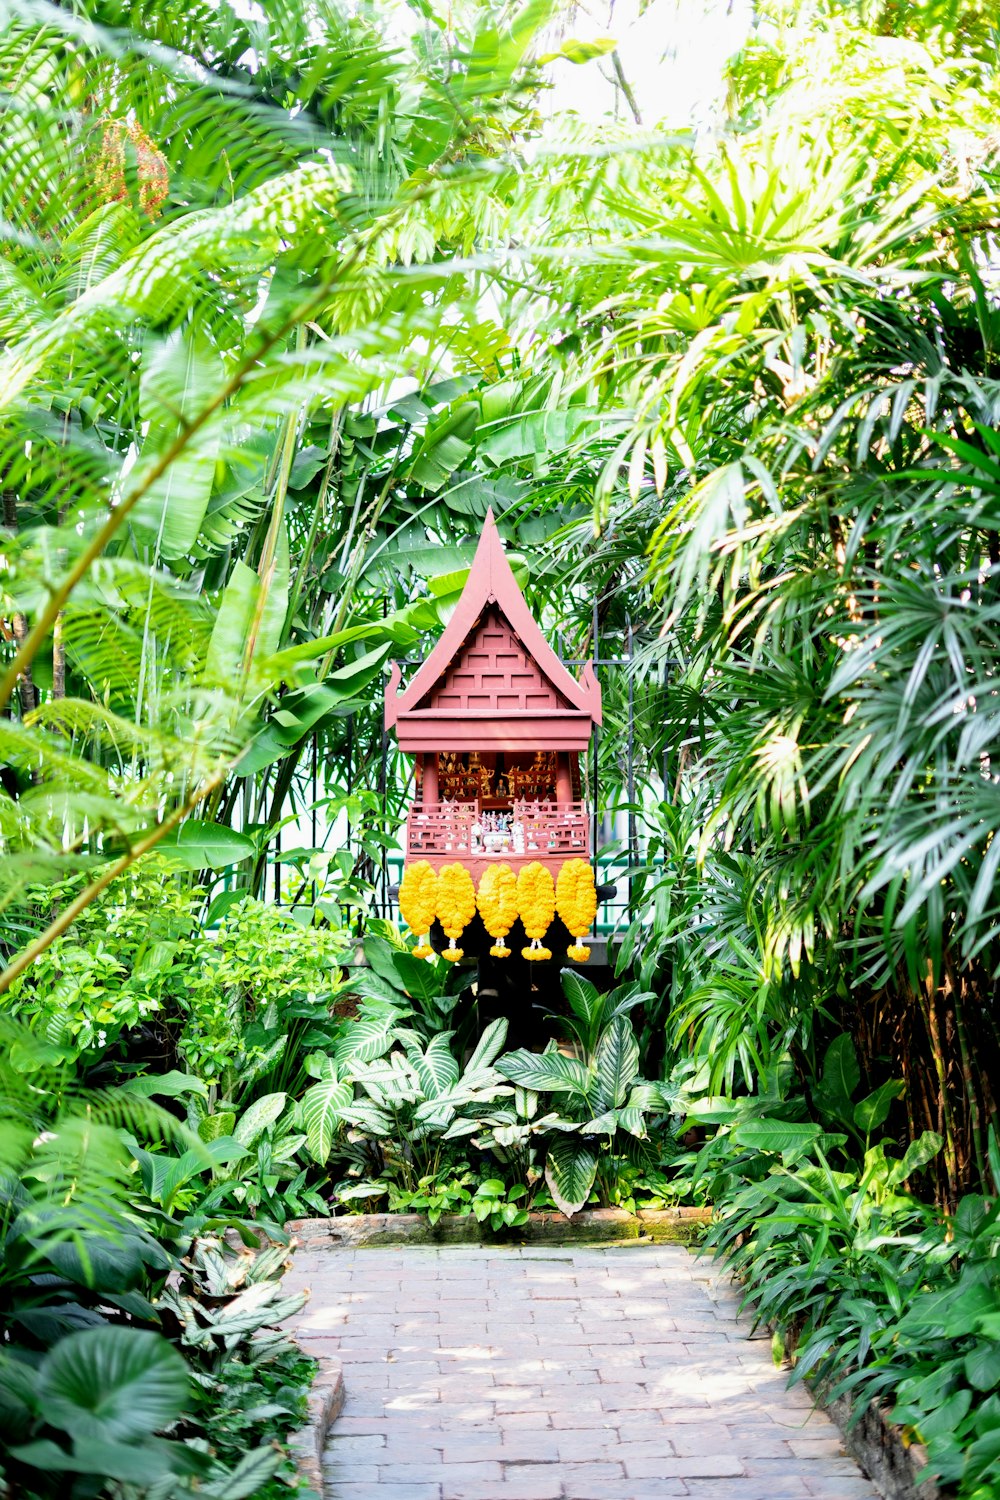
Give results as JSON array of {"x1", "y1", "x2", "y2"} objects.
[{"x1": 703, "y1": 1124, "x2": 1000, "y2": 1500}]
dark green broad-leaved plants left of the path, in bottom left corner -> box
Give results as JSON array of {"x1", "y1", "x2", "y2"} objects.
[{"x1": 0, "y1": 1019, "x2": 309, "y2": 1500}]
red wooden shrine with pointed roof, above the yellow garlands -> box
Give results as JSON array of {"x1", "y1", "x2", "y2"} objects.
[{"x1": 385, "y1": 510, "x2": 601, "y2": 884}]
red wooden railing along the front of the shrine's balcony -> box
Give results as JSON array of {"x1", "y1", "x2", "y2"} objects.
[{"x1": 406, "y1": 801, "x2": 591, "y2": 861}]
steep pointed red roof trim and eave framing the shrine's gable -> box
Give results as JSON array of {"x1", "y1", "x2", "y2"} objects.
[{"x1": 385, "y1": 510, "x2": 601, "y2": 750}]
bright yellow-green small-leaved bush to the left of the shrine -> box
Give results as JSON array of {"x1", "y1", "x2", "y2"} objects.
[{"x1": 7, "y1": 858, "x2": 349, "y2": 1134}]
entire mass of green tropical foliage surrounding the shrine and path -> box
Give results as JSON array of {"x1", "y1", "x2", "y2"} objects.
[{"x1": 0, "y1": 0, "x2": 1000, "y2": 1497}]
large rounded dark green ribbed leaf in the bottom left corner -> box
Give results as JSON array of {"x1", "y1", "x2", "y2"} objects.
[{"x1": 37, "y1": 1328, "x2": 190, "y2": 1442}]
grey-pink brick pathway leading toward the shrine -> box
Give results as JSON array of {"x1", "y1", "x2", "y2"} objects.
[{"x1": 281, "y1": 1245, "x2": 876, "y2": 1500}]
